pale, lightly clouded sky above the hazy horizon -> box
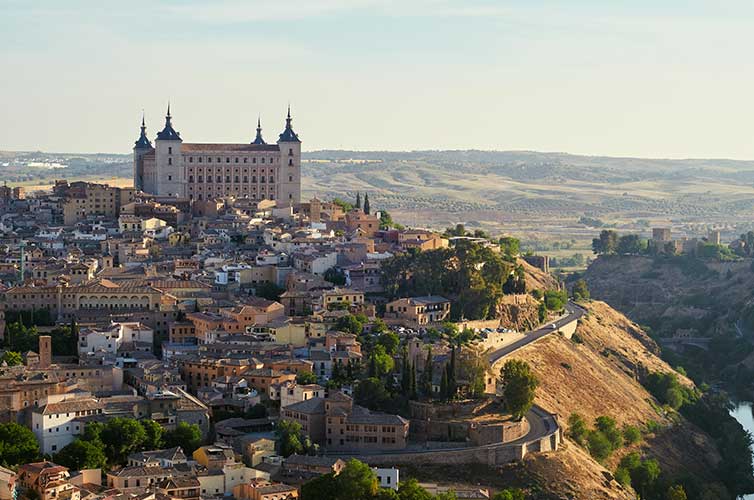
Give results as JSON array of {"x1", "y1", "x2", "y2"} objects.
[{"x1": 0, "y1": 0, "x2": 754, "y2": 159}]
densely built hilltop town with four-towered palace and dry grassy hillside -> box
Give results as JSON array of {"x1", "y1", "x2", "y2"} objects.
[{"x1": 0, "y1": 110, "x2": 740, "y2": 500}]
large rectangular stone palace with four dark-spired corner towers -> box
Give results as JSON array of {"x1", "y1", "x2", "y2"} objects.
[{"x1": 134, "y1": 105, "x2": 301, "y2": 206}]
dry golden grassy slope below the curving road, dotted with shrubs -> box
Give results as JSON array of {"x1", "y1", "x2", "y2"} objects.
[{"x1": 511, "y1": 302, "x2": 719, "y2": 498}]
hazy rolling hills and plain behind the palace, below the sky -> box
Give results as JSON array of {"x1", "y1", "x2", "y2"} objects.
[{"x1": 0, "y1": 150, "x2": 754, "y2": 233}]
